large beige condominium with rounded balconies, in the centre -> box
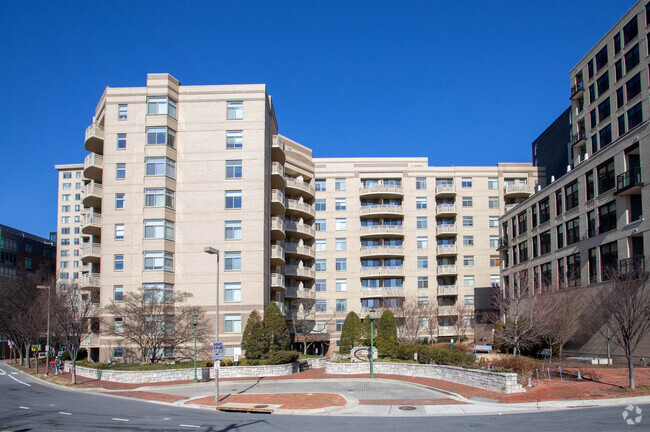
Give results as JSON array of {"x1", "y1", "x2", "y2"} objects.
[{"x1": 59, "y1": 74, "x2": 539, "y2": 361}]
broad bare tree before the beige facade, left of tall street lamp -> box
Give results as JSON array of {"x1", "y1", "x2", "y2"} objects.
[{"x1": 105, "y1": 287, "x2": 209, "y2": 363}]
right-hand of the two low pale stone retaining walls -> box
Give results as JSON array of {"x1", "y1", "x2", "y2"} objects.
[{"x1": 325, "y1": 362, "x2": 526, "y2": 393}]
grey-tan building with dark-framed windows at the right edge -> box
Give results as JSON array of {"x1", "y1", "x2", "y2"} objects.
[{"x1": 500, "y1": 2, "x2": 650, "y2": 353}]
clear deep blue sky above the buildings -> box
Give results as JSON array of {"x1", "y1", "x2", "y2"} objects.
[{"x1": 0, "y1": 0, "x2": 634, "y2": 236}]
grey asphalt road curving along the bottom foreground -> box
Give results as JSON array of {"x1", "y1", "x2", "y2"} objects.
[{"x1": 0, "y1": 365, "x2": 650, "y2": 432}]
